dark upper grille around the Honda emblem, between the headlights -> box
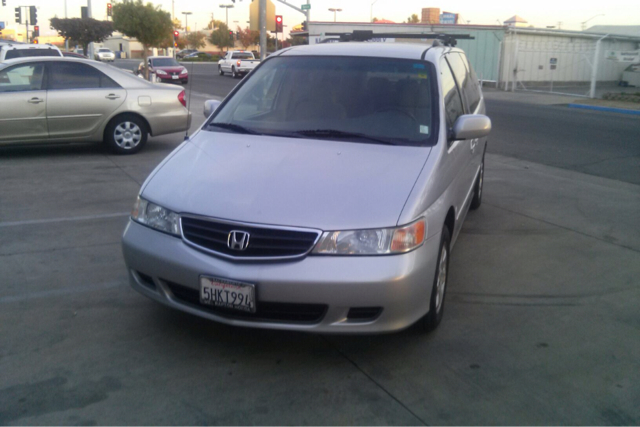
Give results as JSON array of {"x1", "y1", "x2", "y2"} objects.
[{"x1": 182, "y1": 217, "x2": 319, "y2": 258}]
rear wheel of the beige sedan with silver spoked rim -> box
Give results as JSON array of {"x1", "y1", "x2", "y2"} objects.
[{"x1": 104, "y1": 114, "x2": 149, "y2": 154}]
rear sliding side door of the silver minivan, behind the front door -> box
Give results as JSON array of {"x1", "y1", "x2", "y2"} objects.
[{"x1": 446, "y1": 52, "x2": 478, "y2": 219}]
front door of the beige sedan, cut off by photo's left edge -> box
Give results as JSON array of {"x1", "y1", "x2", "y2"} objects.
[{"x1": 0, "y1": 62, "x2": 49, "y2": 143}]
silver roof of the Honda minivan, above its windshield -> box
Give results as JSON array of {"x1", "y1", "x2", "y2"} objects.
[{"x1": 279, "y1": 42, "x2": 462, "y2": 61}]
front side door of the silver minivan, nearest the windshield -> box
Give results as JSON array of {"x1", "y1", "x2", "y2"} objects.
[{"x1": 440, "y1": 57, "x2": 471, "y2": 237}]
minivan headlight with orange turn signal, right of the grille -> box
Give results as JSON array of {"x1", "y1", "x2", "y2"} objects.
[{"x1": 313, "y1": 218, "x2": 427, "y2": 255}]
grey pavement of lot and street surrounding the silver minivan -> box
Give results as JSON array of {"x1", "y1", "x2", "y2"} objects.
[{"x1": 0, "y1": 69, "x2": 640, "y2": 425}]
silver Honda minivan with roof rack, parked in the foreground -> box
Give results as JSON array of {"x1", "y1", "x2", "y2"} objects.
[{"x1": 122, "y1": 43, "x2": 491, "y2": 333}]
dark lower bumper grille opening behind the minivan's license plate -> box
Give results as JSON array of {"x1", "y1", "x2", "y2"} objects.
[{"x1": 165, "y1": 281, "x2": 327, "y2": 323}]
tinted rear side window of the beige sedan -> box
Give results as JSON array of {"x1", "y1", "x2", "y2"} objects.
[{"x1": 49, "y1": 62, "x2": 120, "y2": 90}]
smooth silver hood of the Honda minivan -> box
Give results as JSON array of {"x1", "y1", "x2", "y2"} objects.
[{"x1": 142, "y1": 131, "x2": 431, "y2": 230}]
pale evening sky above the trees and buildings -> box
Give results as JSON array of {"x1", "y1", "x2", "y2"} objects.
[{"x1": 0, "y1": 0, "x2": 640, "y2": 35}]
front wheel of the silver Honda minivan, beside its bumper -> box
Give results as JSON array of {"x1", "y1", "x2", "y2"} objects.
[{"x1": 420, "y1": 225, "x2": 451, "y2": 332}]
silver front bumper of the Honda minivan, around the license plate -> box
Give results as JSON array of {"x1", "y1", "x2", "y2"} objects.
[{"x1": 122, "y1": 220, "x2": 440, "y2": 334}]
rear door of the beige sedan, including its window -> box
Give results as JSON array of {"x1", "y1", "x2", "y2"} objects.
[{"x1": 47, "y1": 61, "x2": 127, "y2": 139}]
